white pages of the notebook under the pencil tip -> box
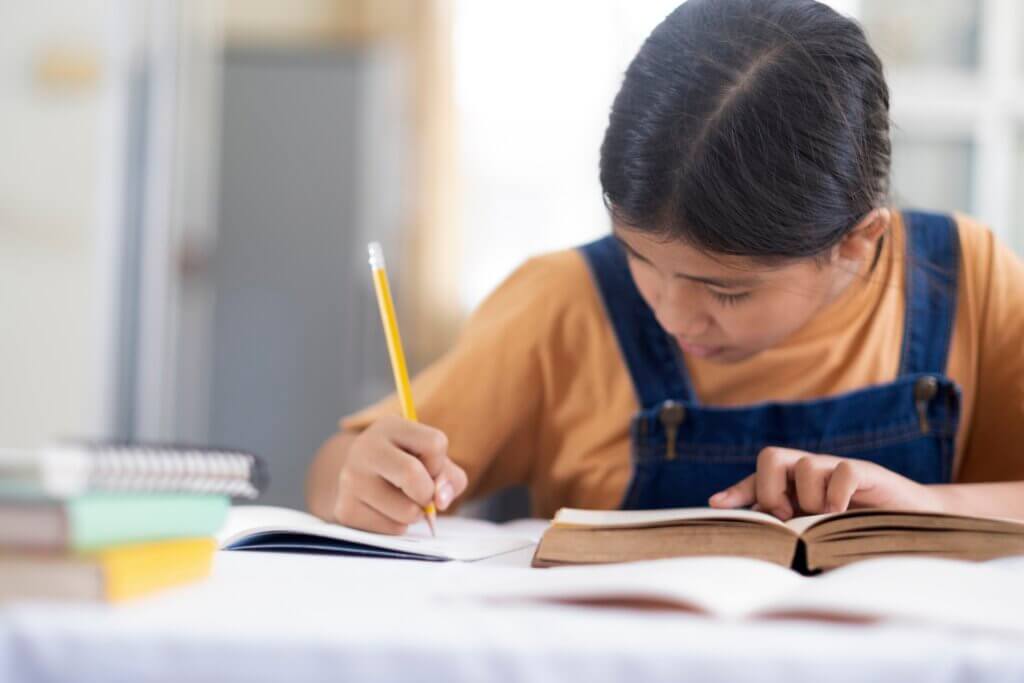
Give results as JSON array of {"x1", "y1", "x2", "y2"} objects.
[{"x1": 217, "y1": 505, "x2": 534, "y2": 561}]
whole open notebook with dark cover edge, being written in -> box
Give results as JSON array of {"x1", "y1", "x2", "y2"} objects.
[{"x1": 217, "y1": 505, "x2": 539, "y2": 562}]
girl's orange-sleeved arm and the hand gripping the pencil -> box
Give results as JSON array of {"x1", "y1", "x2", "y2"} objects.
[{"x1": 306, "y1": 253, "x2": 565, "y2": 533}]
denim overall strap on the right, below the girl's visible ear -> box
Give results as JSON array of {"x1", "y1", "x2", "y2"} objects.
[{"x1": 899, "y1": 211, "x2": 959, "y2": 375}]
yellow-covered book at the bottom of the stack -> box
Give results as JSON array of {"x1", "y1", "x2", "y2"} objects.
[{"x1": 0, "y1": 538, "x2": 216, "y2": 601}]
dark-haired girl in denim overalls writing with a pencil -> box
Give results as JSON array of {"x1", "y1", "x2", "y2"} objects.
[{"x1": 308, "y1": 0, "x2": 1024, "y2": 533}]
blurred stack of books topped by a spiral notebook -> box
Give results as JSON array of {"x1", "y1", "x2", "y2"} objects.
[{"x1": 0, "y1": 443, "x2": 265, "y2": 601}]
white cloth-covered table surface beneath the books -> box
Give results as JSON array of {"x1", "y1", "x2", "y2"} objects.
[{"x1": 0, "y1": 551, "x2": 1024, "y2": 683}]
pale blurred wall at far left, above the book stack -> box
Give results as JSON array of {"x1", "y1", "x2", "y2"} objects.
[{"x1": 0, "y1": 0, "x2": 112, "y2": 446}]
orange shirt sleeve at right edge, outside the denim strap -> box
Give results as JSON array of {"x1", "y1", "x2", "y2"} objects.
[{"x1": 959, "y1": 224, "x2": 1024, "y2": 481}]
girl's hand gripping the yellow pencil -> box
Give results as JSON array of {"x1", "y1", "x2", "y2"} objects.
[{"x1": 334, "y1": 416, "x2": 466, "y2": 535}]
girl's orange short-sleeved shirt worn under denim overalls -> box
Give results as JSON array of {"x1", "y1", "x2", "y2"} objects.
[{"x1": 341, "y1": 213, "x2": 1024, "y2": 516}]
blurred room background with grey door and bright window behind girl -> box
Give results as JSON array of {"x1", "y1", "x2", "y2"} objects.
[{"x1": 0, "y1": 0, "x2": 1024, "y2": 507}]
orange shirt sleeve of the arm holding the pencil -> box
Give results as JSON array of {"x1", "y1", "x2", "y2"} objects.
[{"x1": 340, "y1": 255, "x2": 564, "y2": 500}]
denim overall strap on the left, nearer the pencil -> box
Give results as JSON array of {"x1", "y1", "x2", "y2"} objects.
[{"x1": 580, "y1": 236, "x2": 695, "y2": 409}]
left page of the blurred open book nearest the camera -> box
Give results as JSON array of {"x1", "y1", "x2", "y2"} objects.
[{"x1": 442, "y1": 557, "x2": 807, "y2": 617}]
